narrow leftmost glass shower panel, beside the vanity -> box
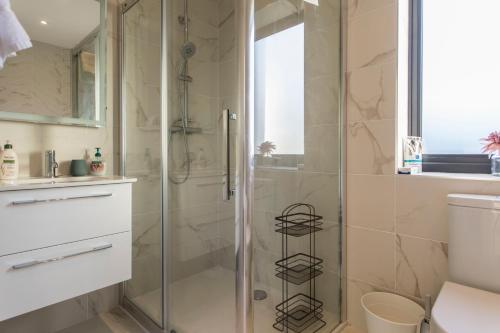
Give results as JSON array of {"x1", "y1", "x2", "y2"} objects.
[{"x1": 122, "y1": 0, "x2": 164, "y2": 326}]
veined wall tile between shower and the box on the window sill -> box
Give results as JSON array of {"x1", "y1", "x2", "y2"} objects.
[{"x1": 347, "y1": 119, "x2": 395, "y2": 175}]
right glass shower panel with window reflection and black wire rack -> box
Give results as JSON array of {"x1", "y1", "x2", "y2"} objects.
[{"x1": 252, "y1": 0, "x2": 341, "y2": 333}]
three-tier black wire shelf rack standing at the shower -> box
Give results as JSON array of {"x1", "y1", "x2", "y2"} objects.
[{"x1": 273, "y1": 203, "x2": 326, "y2": 333}]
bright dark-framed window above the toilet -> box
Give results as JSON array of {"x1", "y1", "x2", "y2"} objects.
[{"x1": 409, "y1": 0, "x2": 500, "y2": 173}]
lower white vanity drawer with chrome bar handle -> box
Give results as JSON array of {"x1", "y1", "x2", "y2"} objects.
[{"x1": 0, "y1": 232, "x2": 132, "y2": 321}]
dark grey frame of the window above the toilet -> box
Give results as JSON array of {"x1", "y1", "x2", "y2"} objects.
[{"x1": 408, "y1": 0, "x2": 491, "y2": 174}]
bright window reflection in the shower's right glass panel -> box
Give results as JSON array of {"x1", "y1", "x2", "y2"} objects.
[{"x1": 255, "y1": 24, "x2": 304, "y2": 155}]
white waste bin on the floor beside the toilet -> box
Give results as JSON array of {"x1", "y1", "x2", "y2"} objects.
[{"x1": 361, "y1": 292, "x2": 425, "y2": 333}]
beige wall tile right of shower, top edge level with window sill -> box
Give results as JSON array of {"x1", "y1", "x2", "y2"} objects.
[{"x1": 347, "y1": 175, "x2": 396, "y2": 231}]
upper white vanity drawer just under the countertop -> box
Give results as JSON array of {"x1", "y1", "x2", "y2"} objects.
[{"x1": 0, "y1": 184, "x2": 132, "y2": 256}]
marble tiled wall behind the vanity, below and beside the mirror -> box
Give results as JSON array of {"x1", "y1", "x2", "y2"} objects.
[{"x1": 0, "y1": 0, "x2": 119, "y2": 333}]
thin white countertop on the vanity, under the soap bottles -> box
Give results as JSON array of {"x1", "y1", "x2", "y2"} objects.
[{"x1": 0, "y1": 176, "x2": 137, "y2": 192}]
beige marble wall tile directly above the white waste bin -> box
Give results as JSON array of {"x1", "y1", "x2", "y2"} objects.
[{"x1": 347, "y1": 227, "x2": 395, "y2": 289}]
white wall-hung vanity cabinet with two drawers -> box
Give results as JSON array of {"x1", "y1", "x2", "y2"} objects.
[{"x1": 0, "y1": 178, "x2": 133, "y2": 321}]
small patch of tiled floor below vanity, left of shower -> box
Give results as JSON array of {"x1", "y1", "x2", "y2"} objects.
[{"x1": 57, "y1": 307, "x2": 147, "y2": 333}]
